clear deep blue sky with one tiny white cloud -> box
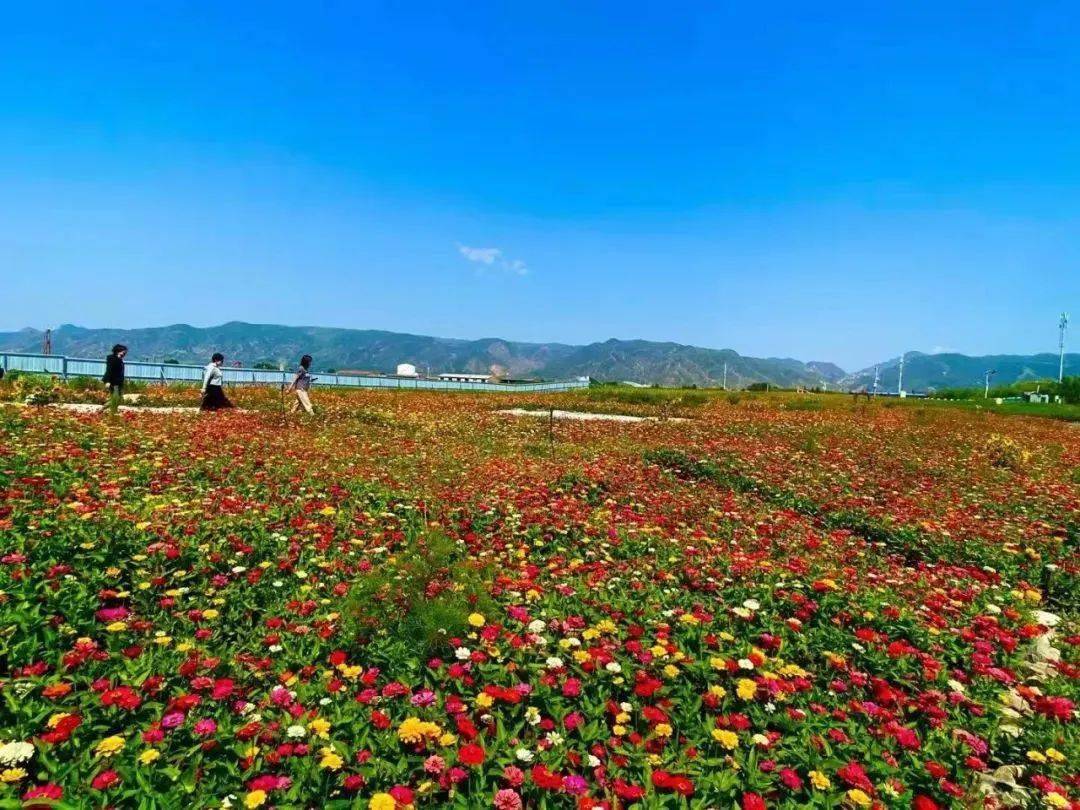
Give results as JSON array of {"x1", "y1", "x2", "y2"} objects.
[{"x1": 0, "y1": 0, "x2": 1080, "y2": 368}]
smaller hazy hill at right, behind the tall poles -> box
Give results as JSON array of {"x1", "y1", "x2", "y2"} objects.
[{"x1": 840, "y1": 352, "x2": 1080, "y2": 391}]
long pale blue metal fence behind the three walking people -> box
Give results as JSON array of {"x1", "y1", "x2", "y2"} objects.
[{"x1": 0, "y1": 352, "x2": 589, "y2": 393}]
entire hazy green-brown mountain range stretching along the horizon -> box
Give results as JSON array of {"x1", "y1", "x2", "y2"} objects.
[{"x1": 0, "y1": 321, "x2": 1080, "y2": 391}]
